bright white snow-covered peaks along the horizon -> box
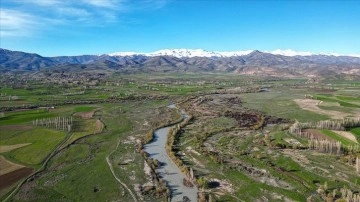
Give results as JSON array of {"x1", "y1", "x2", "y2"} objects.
[{"x1": 108, "y1": 49, "x2": 360, "y2": 58}]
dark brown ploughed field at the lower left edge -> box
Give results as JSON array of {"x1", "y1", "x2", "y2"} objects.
[{"x1": 0, "y1": 167, "x2": 33, "y2": 190}]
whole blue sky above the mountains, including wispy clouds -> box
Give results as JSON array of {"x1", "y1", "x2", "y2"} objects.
[{"x1": 0, "y1": 0, "x2": 360, "y2": 56}]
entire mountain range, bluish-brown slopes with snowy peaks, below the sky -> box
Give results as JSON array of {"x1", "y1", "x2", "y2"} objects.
[{"x1": 0, "y1": 49, "x2": 360, "y2": 79}]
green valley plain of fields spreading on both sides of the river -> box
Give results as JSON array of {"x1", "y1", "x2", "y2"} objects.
[{"x1": 0, "y1": 72, "x2": 360, "y2": 201}]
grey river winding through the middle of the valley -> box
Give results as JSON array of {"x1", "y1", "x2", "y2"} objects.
[{"x1": 144, "y1": 104, "x2": 198, "y2": 202}]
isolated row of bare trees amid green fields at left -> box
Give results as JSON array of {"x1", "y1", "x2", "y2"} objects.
[{"x1": 32, "y1": 117, "x2": 73, "y2": 132}]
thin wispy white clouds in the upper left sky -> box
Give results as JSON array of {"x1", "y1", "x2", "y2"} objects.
[{"x1": 0, "y1": 0, "x2": 166, "y2": 37}]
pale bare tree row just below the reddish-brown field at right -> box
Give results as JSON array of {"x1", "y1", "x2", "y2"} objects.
[{"x1": 309, "y1": 140, "x2": 341, "y2": 155}]
